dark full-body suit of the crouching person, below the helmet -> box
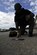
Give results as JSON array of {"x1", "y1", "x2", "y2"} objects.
[{"x1": 14, "y1": 8, "x2": 34, "y2": 35}]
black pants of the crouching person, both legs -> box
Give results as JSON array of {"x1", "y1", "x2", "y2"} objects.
[{"x1": 16, "y1": 19, "x2": 34, "y2": 35}]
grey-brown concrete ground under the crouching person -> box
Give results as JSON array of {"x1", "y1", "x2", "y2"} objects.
[{"x1": 0, "y1": 29, "x2": 37, "y2": 55}]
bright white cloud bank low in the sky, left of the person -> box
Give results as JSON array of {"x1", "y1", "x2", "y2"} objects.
[{"x1": 0, "y1": 11, "x2": 15, "y2": 28}]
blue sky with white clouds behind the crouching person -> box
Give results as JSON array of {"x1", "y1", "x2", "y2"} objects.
[{"x1": 0, "y1": 0, "x2": 37, "y2": 29}]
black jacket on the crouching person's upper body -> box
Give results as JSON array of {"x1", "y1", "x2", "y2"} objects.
[{"x1": 14, "y1": 8, "x2": 34, "y2": 23}]
